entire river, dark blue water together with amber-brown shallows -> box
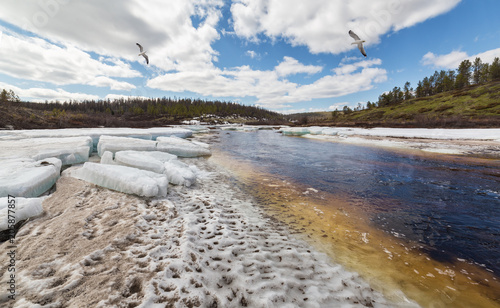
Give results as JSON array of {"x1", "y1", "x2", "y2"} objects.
[{"x1": 212, "y1": 132, "x2": 500, "y2": 307}]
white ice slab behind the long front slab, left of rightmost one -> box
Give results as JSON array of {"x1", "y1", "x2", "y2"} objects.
[{"x1": 97, "y1": 136, "x2": 156, "y2": 156}]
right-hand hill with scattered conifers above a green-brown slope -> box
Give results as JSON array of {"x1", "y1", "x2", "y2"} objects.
[{"x1": 290, "y1": 58, "x2": 500, "y2": 127}]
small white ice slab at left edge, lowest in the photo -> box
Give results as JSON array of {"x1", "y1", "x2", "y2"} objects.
[{"x1": 0, "y1": 197, "x2": 45, "y2": 231}]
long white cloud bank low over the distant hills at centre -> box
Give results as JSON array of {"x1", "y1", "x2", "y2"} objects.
[{"x1": 147, "y1": 58, "x2": 387, "y2": 108}]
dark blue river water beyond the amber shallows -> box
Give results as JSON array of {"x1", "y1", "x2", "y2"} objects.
[{"x1": 210, "y1": 131, "x2": 500, "y2": 306}]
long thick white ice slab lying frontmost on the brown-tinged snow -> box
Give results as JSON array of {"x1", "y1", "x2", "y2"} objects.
[{"x1": 69, "y1": 162, "x2": 168, "y2": 197}]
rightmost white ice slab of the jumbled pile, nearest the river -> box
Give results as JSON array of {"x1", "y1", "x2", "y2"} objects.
[{"x1": 156, "y1": 137, "x2": 212, "y2": 157}]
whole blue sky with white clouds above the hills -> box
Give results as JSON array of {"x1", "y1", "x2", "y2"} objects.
[{"x1": 0, "y1": 0, "x2": 500, "y2": 113}]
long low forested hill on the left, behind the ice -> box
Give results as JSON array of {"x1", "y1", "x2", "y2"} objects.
[{"x1": 0, "y1": 95, "x2": 285, "y2": 129}]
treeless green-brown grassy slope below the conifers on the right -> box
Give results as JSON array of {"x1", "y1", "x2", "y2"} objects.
[{"x1": 300, "y1": 81, "x2": 500, "y2": 127}]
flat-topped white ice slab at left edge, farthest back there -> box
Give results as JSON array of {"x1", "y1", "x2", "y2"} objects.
[{"x1": 0, "y1": 137, "x2": 93, "y2": 165}]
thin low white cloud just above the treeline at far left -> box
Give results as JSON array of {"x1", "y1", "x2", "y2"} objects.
[{"x1": 0, "y1": 82, "x2": 99, "y2": 102}]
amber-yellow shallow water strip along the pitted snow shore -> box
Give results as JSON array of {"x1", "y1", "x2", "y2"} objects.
[{"x1": 212, "y1": 152, "x2": 500, "y2": 307}]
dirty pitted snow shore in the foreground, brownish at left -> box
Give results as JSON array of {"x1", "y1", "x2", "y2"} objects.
[{"x1": 0, "y1": 158, "x2": 408, "y2": 307}]
